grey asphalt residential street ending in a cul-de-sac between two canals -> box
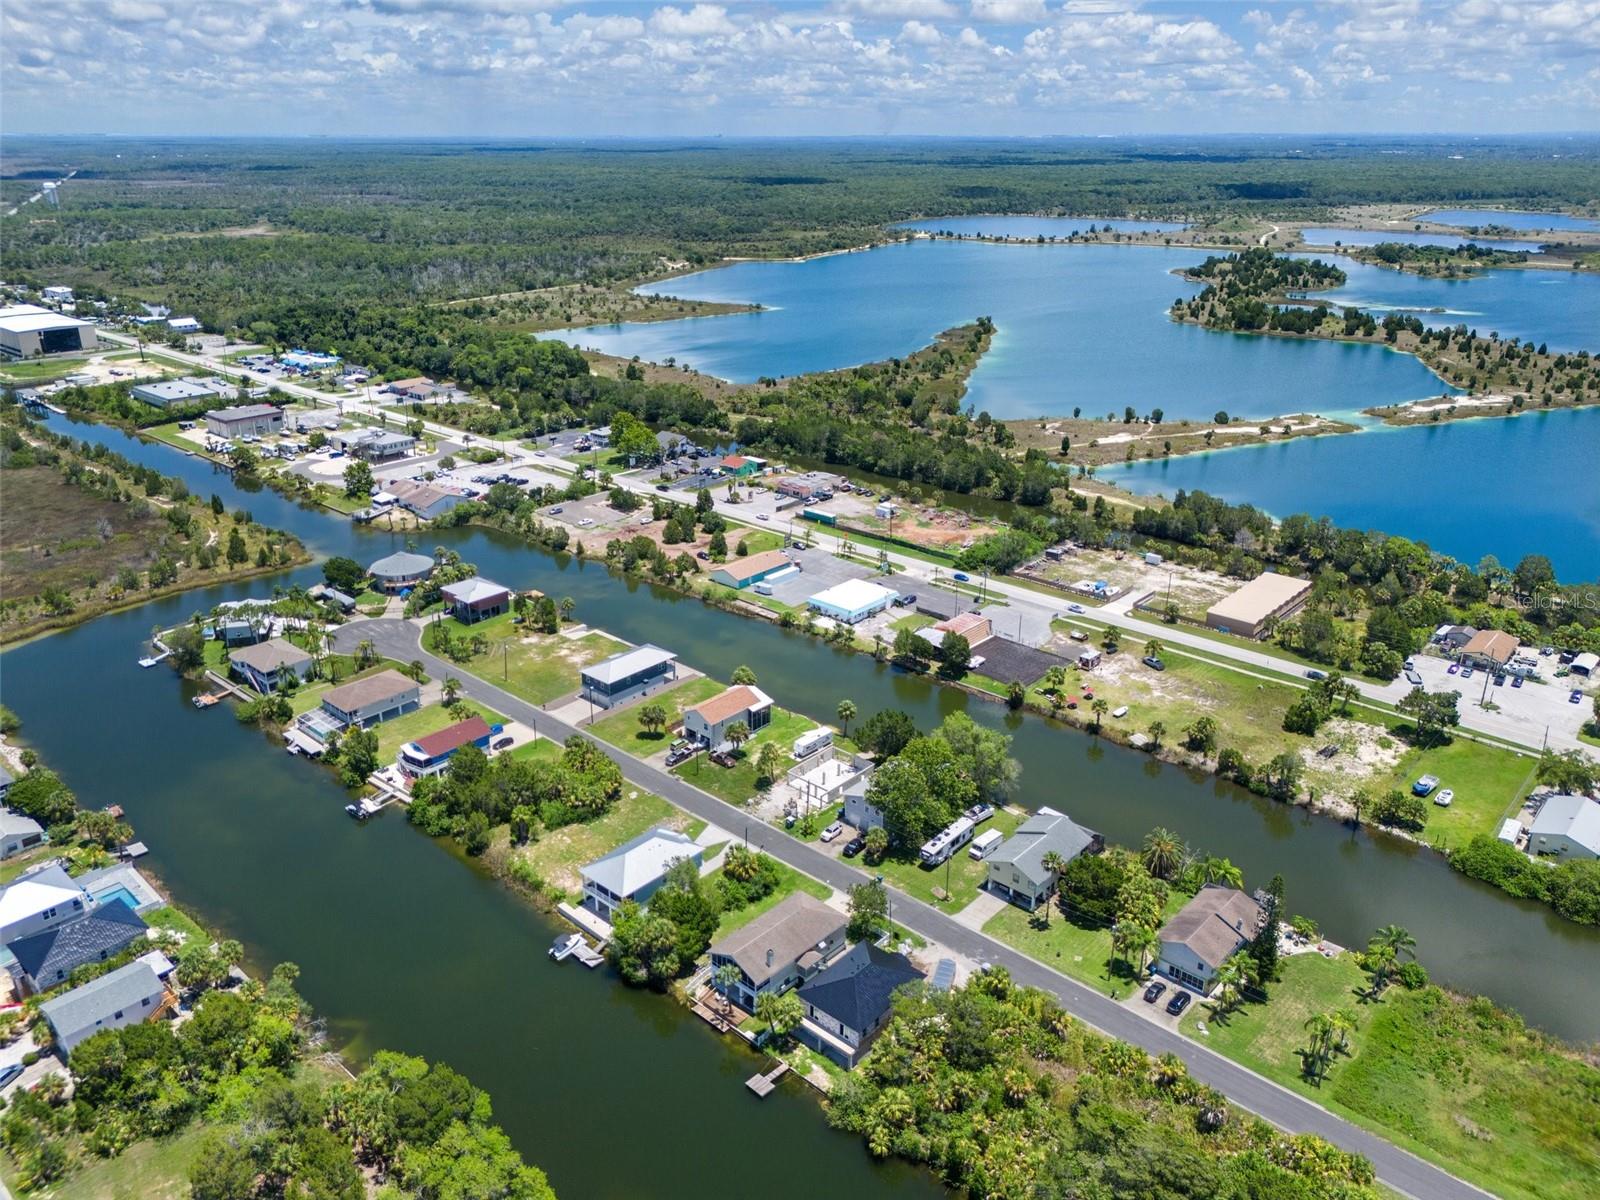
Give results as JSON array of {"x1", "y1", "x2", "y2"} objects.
[{"x1": 334, "y1": 619, "x2": 1486, "y2": 1200}]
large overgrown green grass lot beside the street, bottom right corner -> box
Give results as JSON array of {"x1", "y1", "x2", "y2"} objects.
[{"x1": 1181, "y1": 954, "x2": 1600, "y2": 1200}]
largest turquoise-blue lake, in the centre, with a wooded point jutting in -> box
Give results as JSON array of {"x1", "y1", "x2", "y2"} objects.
[{"x1": 563, "y1": 240, "x2": 1443, "y2": 421}]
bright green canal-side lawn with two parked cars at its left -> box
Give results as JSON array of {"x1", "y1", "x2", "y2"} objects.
[{"x1": 1373, "y1": 738, "x2": 1539, "y2": 850}]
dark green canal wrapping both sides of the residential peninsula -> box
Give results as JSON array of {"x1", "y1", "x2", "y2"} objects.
[{"x1": 9, "y1": 418, "x2": 1600, "y2": 1062}]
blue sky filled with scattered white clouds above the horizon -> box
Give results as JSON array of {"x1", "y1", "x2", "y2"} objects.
[{"x1": 9, "y1": 0, "x2": 1600, "y2": 136}]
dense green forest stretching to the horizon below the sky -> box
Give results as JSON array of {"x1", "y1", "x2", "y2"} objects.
[{"x1": 6, "y1": 138, "x2": 1600, "y2": 328}]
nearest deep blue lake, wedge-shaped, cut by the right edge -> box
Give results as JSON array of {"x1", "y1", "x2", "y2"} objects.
[{"x1": 1099, "y1": 408, "x2": 1600, "y2": 582}]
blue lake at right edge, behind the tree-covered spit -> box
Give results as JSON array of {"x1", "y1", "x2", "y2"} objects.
[{"x1": 1315, "y1": 258, "x2": 1600, "y2": 350}]
